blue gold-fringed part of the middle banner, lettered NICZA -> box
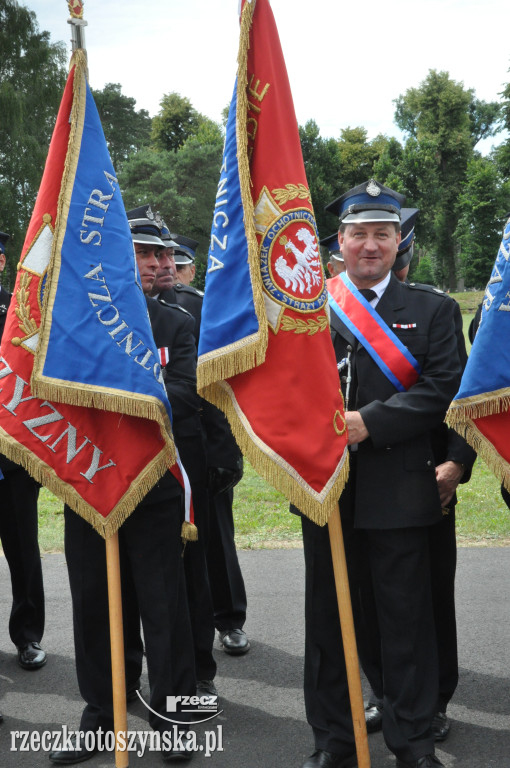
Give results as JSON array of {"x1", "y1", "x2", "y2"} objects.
[{"x1": 198, "y1": 79, "x2": 267, "y2": 376}]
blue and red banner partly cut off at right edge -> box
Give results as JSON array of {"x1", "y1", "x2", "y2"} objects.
[{"x1": 446, "y1": 214, "x2": 510, "y2": 490}]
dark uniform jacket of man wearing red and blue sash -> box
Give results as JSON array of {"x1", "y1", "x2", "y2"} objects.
[{"x1": 331, "y1": 275, "x2": 461, "y2": 529}]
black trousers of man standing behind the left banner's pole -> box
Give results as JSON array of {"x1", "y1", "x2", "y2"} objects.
[{"x1": 65, "y1": 498, "x2": 195, "y2": 731}]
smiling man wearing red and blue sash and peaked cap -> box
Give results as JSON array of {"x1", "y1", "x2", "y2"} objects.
[{"x1": 296, "y1": 179, "x2": 461, "y2": 768}]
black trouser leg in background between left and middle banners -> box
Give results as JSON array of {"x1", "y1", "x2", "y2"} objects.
[{"x1": 207, "y1": 489, "x2": 247, "y2": 632}]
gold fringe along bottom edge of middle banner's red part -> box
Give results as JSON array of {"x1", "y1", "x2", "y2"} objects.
[{"x1": 204, "y1": 382, "x2": 349, "y2": 525}]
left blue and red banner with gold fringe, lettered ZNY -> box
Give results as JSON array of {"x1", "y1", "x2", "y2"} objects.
[{"x1": 0, "y1": 50, "x2": 175, "y2": 537}]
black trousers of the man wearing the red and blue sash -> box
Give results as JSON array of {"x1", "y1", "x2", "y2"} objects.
[{"x1": 302, "y1": 505, "x2": 438, "y2": 762}]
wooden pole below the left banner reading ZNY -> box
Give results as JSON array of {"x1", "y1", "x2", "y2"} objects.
[{"x1": 106, "y1": 531, "x2": 129, "y2": 768}]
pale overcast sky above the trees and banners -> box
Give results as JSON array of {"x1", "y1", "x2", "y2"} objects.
[{"x1": 25, "y1": 0, "x2": 510, "y2": 151}]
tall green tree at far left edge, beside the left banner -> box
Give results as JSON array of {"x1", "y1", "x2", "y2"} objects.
[{"x1": 0, "y1": 0, "x2": 67, "y2": 285}]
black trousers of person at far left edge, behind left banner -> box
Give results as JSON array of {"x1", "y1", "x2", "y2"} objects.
[{"x1": 0, "y1": 464, "x2": 44, "y2": 645}]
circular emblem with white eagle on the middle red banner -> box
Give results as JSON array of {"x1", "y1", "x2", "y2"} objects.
[{"x1": 260, "y1": 209, "x2": 327, "y2": 312}]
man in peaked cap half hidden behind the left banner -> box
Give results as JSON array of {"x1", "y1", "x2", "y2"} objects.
[{"x1": 50, "y1": 205, "x2": 199, "y2": 765}]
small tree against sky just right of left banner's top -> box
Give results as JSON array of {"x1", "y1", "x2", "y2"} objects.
[{"x1": 92, "y1": 83, "x2": 152, "y2": 173}]
